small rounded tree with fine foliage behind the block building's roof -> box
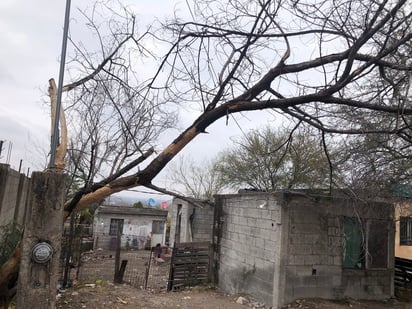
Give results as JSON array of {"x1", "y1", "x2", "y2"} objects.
[{"x1": 216, "y1": 127, "x2": 329, "y2": 191}]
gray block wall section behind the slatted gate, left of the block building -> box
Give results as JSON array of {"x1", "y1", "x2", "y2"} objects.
[{"x1": 169, "y1": 198, "x2": 214, "y2": 245}]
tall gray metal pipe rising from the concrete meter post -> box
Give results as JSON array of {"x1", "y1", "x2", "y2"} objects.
[{"x1": 49, "y1": 0, "x2": 71, "y2": 169}]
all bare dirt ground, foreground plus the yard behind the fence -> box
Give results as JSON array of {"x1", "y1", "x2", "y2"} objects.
[{"x1": 57, "y1": 252, "x2": 412, "y2": 309}]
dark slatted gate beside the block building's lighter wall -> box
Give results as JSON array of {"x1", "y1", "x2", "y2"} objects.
[{"x1": 167, "y1": 242, "x2": 212, "y2": 291}]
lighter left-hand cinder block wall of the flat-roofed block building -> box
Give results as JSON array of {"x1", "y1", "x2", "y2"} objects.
[{"x1": 216, "y1": 193, "x2": 281, "y2": 305}]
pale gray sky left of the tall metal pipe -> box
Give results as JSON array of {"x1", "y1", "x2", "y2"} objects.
[{"x1": 0, "y1": 0, "x2": 64, "y2": 171}]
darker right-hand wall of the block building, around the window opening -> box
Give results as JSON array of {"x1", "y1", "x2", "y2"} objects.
[{"x1": 281, "y1": 194, "x2": 394, "y2": 303}]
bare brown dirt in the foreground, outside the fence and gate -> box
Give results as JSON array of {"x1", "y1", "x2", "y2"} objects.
[{"x1": 57, "y1": 283, "x2": 412, "y2": 309}]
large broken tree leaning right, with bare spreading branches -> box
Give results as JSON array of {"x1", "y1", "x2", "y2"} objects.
[{"x1": 0, "y1": 0, "x2": 412, "y2": 300}]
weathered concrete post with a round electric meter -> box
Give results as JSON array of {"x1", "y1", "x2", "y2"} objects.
[{"x1": 17, "y1": 172, "x2": 66, "y2": 309}]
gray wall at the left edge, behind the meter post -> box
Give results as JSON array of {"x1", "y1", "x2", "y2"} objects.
[{"x1": 0, "y1": 164, "x2": 30, "y2": 226}]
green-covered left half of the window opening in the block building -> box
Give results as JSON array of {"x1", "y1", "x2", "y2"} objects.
[{"x1": 343, "y1": 217, "x2": 364, "y2": 269}]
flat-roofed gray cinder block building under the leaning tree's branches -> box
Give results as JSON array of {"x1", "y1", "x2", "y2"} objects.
[{"x1": 171, "y1": 192, "x2": 395, "y2": 308}]
